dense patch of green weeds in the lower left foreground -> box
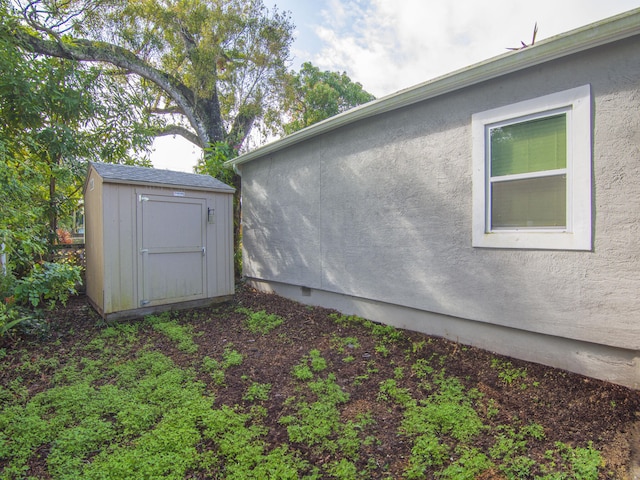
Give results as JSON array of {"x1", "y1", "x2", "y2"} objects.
[{"x1": 0, "y1": 352, "x2": 212, "y2": 478}]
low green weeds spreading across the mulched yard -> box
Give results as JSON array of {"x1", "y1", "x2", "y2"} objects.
[{"x1": 0, "y1": 290, "x2": 634, "y2": 480}]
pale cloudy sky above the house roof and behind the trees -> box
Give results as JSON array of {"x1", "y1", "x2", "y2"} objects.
[{"x1": 151, "y1": 0, "x2": 640, "y2": 172}]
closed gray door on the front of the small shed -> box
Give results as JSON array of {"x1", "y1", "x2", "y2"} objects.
[{"x1": 138, "y1": 194, "x2": 207, "y2": 306}]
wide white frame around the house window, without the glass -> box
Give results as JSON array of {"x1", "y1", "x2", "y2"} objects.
[{"x1": 471, "y1": 85, "x2": 592, "y2": 250}]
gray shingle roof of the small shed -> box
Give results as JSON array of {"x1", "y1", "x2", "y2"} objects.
[{"x1": 90, "y1": 162, "x2": 234, "y2": 192}]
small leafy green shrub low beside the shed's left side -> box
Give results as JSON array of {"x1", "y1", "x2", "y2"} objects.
[{"x1": 15, "y1": 263, "x2": 81, "y2": 309}]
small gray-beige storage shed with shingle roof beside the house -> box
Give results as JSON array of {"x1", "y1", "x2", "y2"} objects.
[{"x1": 84, "y1": 163, "x2": 234, "y2": 320}]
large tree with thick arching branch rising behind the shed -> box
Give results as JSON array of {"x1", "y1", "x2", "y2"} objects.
[{"x1": 5, "y1": 0, "x2": 293, "y2": 149}]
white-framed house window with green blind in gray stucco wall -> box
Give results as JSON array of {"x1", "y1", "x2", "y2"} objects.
[{"x1": 472, "y1": 85, "x2": 591, "y2": 250}]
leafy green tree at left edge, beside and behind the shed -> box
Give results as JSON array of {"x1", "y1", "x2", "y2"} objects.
[{"x1": 0, "y1": 2, "x2": 158, "y2": 276}]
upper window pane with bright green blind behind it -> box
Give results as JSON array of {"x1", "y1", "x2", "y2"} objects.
[{"x1": 491, "y1": 114, "x2": 567, "y2": 177}]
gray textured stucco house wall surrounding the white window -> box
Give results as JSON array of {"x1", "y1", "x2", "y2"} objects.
[{"x1": 241, "y1": 37, "x2": 640, "y2": 382}]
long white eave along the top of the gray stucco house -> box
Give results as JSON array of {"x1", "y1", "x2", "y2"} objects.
[{"x1": 227, "y1": 8, "x2": 640, "y2": 166}]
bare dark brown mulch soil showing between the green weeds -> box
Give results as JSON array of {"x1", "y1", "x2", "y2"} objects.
[{"x1": 0, "y1": 287, "x2": 640, "y2": 480}]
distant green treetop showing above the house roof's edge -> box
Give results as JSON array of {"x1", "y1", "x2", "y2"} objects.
[{"x1": 283, "y1": 62, "x2": 375, "y2": 134}]
